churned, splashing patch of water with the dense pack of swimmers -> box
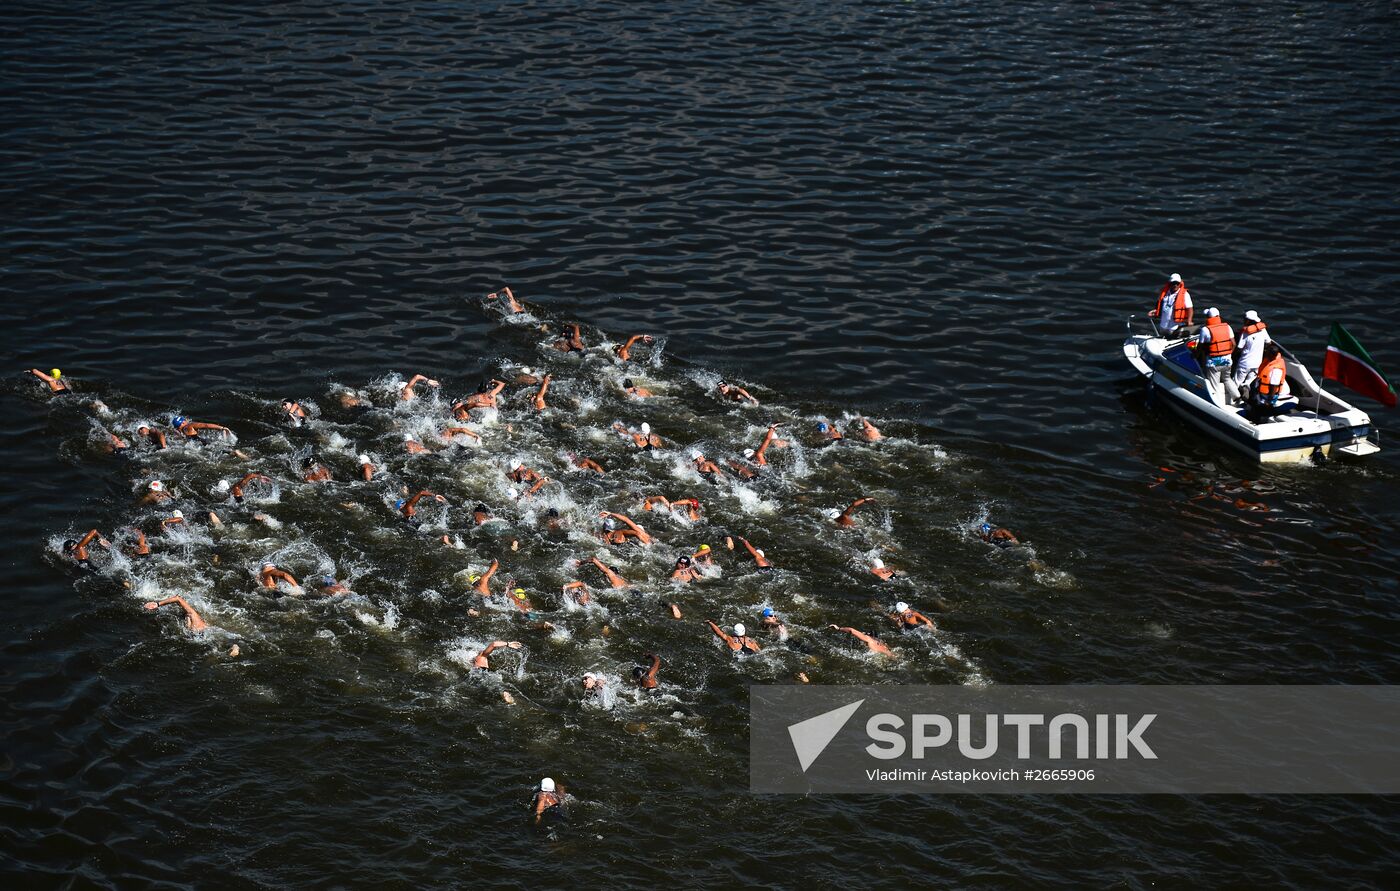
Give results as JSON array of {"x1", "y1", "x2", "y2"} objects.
[{"x1": 24, "y1": 288, "x2": 1072, "y2": 717}]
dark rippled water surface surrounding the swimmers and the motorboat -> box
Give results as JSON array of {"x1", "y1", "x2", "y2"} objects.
[{"x1": 0, "y1": 0, "x2": 1400, "y2": 888}]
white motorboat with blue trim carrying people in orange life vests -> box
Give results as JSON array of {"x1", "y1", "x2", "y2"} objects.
[{"x1": 1123, "y1": 317, "x2": 1380, "y2": 464}]
